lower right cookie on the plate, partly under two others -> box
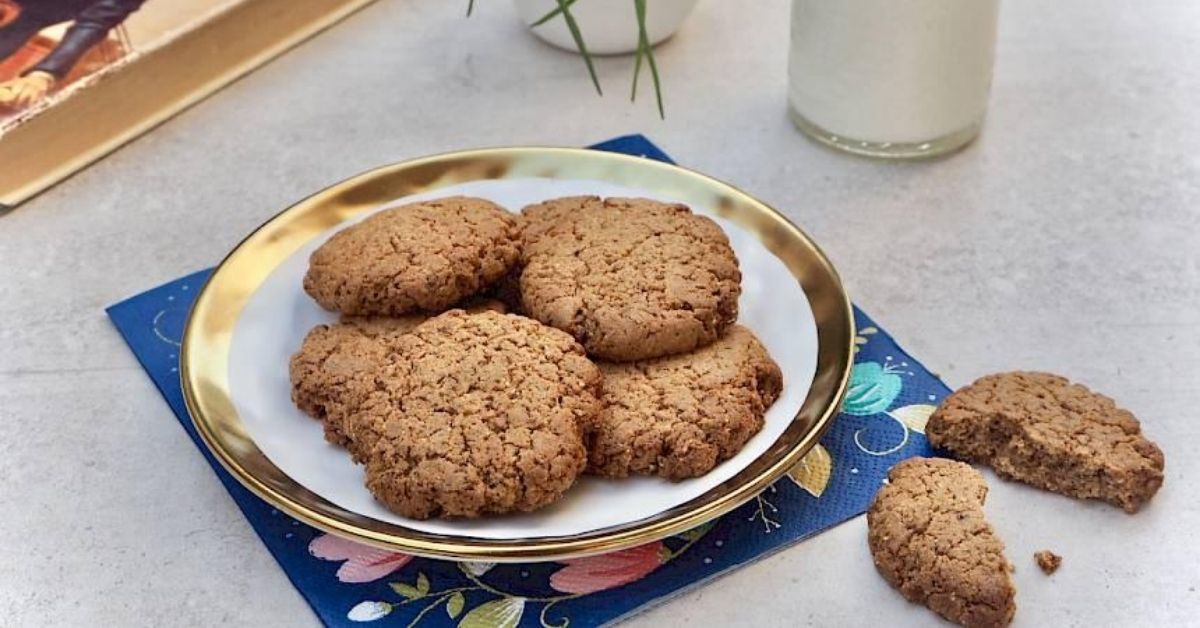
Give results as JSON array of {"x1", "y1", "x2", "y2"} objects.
[{"x1": 588, "y1": 325, "x2": 784, "y2": 480}]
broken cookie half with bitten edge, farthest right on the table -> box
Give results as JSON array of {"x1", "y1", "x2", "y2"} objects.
[{"x1": 925, "y1": 371, "x2": 1164, "y2": 513}]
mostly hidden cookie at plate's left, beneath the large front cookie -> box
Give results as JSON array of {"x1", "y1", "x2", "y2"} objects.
[{"x1": 288, "y1": 299, "x2": 504, "y2": 451}]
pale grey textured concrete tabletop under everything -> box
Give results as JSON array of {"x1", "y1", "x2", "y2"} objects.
[{"x1": 0, "y1": 0, "x2": 1200, "y2": 626}]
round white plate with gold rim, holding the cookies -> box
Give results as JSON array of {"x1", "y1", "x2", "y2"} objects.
[{"x1": 182, "y1": 148, "x2": 853, "y2": 561}]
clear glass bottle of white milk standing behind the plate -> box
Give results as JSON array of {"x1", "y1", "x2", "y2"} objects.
[{"x1": 788, "y1": 0, "x2": 1000, "y2": 159}]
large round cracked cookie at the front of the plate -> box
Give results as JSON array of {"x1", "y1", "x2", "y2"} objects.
[{"x1": 347, "y1": 310, "x2": 601, "y2": 519}]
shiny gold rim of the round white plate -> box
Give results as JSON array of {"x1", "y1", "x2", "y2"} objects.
[{"x1": 180, "y1": 146, "x2": 854, "y2": 562}]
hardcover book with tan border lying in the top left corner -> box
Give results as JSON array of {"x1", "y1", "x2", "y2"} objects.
[{"x1": 0, "y1": 0, "x2": 371, "y2": 211}]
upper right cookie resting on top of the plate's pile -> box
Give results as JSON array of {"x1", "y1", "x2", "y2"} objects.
[{"x1": 520, "y1": 197, "x2": 742, "y2": 361}]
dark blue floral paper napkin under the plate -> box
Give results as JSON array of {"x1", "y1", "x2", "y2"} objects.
[{"x1": 108, "y1": 136, "x2": 949, "y2": 628}]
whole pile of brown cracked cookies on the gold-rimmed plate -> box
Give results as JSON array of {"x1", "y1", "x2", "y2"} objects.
[{"x1": 290, "y1": 197, "x2": 782, "y2": 519}]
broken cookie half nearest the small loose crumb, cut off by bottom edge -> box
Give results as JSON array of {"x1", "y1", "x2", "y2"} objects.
[{"x1": 866, "y1": 457, "x2": 1016, "y2": 627}]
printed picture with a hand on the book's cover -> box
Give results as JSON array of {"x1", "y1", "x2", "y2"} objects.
[{"x1": 0, "y1": 0, "x2": 228, "y2": 134}]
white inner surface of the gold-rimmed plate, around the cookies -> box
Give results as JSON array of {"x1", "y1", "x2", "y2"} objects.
[{"x1": 229, "y1": 178, "x2": 817, "y2": 539}]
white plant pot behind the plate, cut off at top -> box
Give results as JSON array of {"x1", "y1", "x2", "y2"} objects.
[{"x1": 514, "y1": 0, "x2": 700, "y2": 54}]
